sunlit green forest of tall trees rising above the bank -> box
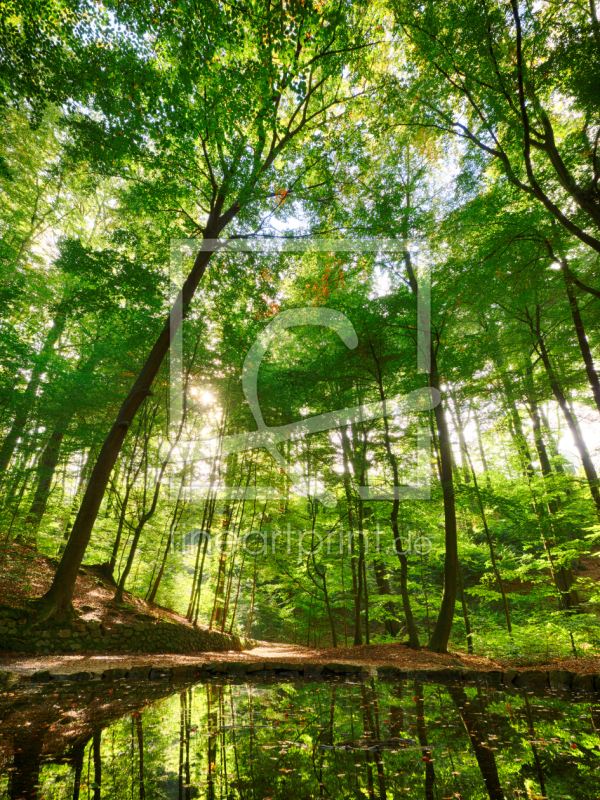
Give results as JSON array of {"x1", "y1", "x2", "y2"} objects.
[{"x1": 0, "y1": 0, "x2": 600, "y2": 664}]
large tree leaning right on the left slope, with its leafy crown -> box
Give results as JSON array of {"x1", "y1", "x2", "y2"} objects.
[{"x1": 34, "y1": 0, "x2": 380, "y2": 618}]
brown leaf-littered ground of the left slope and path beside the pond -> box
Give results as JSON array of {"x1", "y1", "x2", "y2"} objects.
[{"x1": 0, "y1": 545, "x2": 600, "y2": 674}]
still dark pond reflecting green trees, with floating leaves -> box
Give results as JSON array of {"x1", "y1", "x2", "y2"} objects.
[{"x1": 0, "y1": 678, "x2": 600, "y2": 800}]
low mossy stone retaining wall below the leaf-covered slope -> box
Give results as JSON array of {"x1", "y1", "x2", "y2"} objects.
[{"x1": 0, "y1": 606, "x2": 242, "y2": 654}]
